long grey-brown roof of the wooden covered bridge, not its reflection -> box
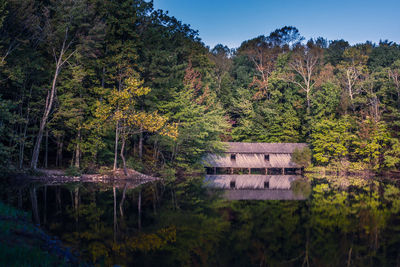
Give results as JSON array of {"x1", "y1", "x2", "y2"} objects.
[{"x1": 224, "y1": 142, "x2": 307, "y2": 154}]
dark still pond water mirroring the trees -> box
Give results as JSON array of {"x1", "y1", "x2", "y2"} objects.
[{"x1": 1, "y1": 177, "x2": 400, "y2": 266}]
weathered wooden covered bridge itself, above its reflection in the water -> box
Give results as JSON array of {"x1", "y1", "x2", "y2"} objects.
[{"x1": 205, "y1": 142, "x2": 307, "y2": 178}]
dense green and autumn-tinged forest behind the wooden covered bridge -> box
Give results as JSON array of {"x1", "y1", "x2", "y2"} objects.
[{"x1": 0, "y1": 0, "x2": 400, "y2": 179}]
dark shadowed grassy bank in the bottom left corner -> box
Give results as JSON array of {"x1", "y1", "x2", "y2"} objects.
[{"x1": 0, "y1": 202, "x2": 75, "y2": 266}]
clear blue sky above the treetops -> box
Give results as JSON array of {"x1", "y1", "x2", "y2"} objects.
[{"x1": 154, "y1": 0, "x2": 400, "y2": 48}]
